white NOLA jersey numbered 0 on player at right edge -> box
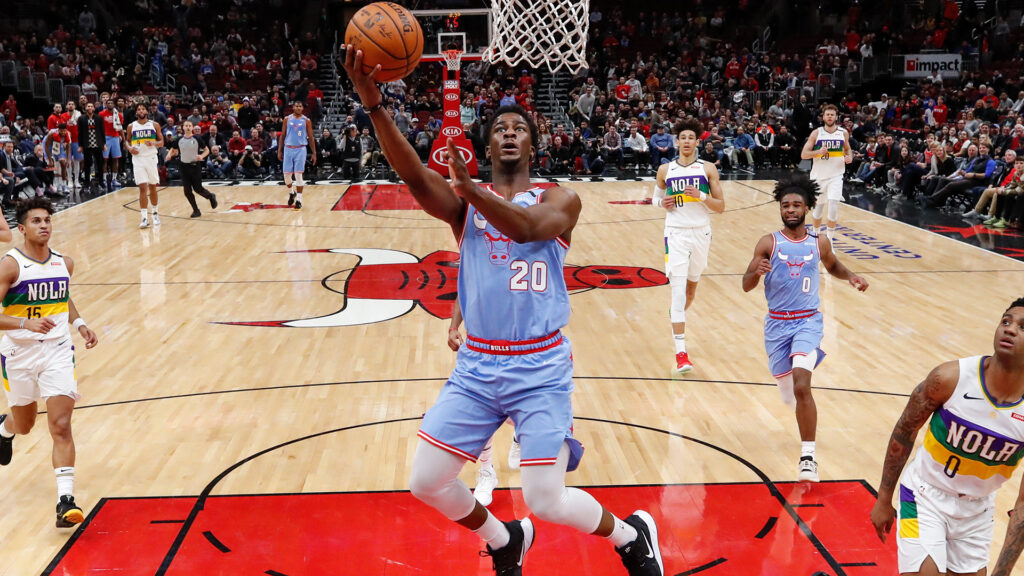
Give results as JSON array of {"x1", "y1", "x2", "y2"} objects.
[{"x1": 911, "y1": 356, "x2": 1024, "y2": 498}]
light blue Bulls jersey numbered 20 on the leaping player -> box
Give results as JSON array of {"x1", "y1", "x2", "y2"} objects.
[{"x1": 459, "y1": 186, "x2": 569, "y2": 340}]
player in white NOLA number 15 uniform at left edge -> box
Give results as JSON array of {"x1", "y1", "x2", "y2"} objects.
[{"x1": 0, "y1": 198, "x2": 96, "y2": 528}]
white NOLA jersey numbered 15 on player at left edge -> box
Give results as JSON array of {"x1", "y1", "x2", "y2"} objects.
[{"x1": 3, "y1": 248, "x2": 71, "y2": 340}]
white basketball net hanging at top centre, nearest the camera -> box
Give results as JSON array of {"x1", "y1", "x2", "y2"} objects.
[{"x1": 483, "y1": 0, "x2": 590, "y2": 72}]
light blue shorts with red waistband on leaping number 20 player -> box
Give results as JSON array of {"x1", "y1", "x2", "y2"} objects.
[{"x1": 419, "y1": 332, "x2": 583, "y2": 470}]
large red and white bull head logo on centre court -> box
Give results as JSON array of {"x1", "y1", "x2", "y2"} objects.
[{"x1": 217, "y1": 248, "x2": 669, "y2": 328}]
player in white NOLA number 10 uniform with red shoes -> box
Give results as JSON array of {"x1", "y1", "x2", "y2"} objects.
[{"x1": 652, "y1": 118, "x2": 725, "y2": 374}]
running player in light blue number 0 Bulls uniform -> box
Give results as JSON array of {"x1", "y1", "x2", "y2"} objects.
[{"x1": 743, "y1": 174, "x2": 867, "y2": 482}]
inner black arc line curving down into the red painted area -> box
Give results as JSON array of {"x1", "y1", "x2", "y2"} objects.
[{"x1": 149, "y1": 416, "x2": 846, "y2": 576}]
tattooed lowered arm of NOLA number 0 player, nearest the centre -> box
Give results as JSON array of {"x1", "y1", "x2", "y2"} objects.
[{"x1": 871, "y1": 362, "x2": 959, "y2": 542}]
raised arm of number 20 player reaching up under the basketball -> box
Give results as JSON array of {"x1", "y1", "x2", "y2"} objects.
[{"x1": 342, "y1": 44, "x2": 466, "y2": 228}]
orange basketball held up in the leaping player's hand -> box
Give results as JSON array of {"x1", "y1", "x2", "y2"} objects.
[{"x1": 345, "y1": 2, "x2": 423, "y2": 82}]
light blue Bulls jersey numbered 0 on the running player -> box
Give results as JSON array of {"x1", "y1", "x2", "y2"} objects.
[{"x1": 765, "y1": 232, "x2": 821, "y2": 312}]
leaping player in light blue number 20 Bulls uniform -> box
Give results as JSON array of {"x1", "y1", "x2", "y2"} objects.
[{"x1": 344, "y1": 45, "x2": 665, "y2": 576}]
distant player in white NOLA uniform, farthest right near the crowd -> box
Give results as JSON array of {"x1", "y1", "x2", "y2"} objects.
[{"x1": 800, "y1": 104, "x2": 853, "y2": 240}]
